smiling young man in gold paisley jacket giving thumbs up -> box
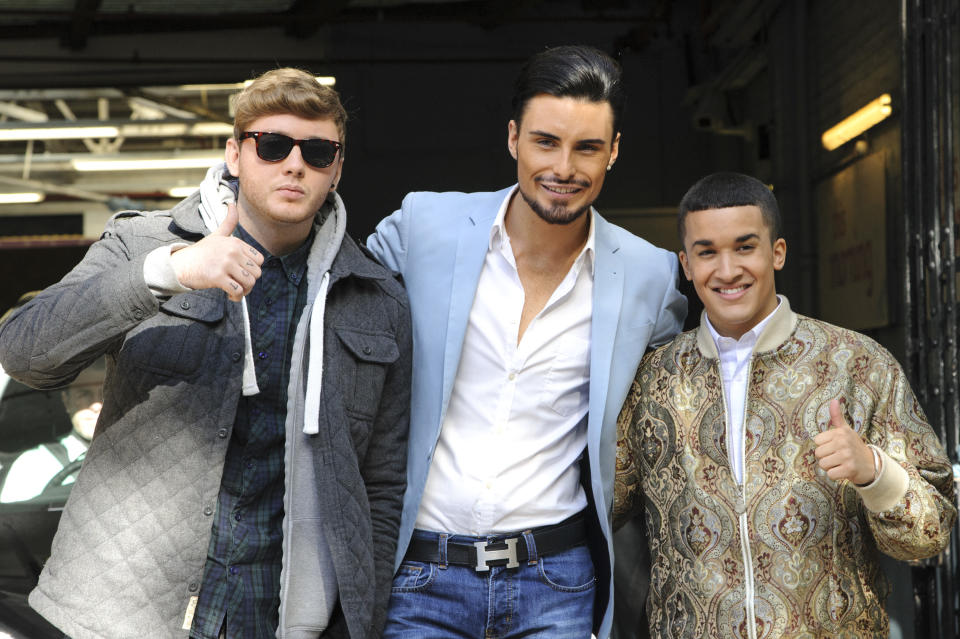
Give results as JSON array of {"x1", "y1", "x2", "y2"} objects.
[{"x1": 615, "y1": 173, "x2": 956, "y2": 639}]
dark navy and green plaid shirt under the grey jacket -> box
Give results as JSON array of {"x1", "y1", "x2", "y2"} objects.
[{"x1": 190, "y1": 226, "x2": 313, "y2": 639}]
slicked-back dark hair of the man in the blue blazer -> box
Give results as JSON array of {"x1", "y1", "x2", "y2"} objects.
[{"x1": 511, "y1": 45, "x2": 626, "y2": 137}]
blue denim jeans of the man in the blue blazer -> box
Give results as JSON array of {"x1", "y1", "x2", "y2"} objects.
[{"x1": 383, "y1": 530, "x2": 596, "y2": 639}]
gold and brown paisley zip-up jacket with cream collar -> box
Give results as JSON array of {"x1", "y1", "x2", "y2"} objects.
[{"x1": 614, "y1": 298, "x2": 956, "y2": 639}]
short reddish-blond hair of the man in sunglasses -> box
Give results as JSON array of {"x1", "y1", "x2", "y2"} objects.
[{"x1": 233, "y1": 67, "x2": 347, "y2": 144}]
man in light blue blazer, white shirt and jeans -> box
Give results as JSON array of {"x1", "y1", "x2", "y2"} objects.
[{"x1": 367, "y1": 47, "x2": 686, "y2": 639}]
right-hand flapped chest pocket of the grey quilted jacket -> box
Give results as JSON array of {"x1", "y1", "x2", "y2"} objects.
[{"x1": 335, "y1": 327, "x2": 400, "y2": 421}]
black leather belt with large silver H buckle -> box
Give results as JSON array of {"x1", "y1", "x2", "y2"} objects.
[{"x1": 404, "y1": 514, "x2": 587, "y2": 572}]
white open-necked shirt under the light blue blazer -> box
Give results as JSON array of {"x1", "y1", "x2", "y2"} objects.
[{"x1": 416, "y1": 189, "x2": 595, "y2": 535}]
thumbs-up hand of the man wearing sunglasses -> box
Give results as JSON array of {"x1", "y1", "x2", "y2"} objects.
[{"x1": 170, "y1": 204, "x2": 263, "y2": 302}]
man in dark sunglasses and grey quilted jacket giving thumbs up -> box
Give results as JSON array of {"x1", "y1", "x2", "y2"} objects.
[{"x1": 0, "y1": 69, "x2": 411, "y2": 639}]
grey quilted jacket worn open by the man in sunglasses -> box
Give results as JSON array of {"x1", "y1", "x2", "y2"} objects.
[{"x1": 0, "y1": 194, "x2": 411, "y2": 639}]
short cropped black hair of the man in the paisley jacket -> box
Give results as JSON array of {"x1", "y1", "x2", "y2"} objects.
[{"x1": 677, "y1": 172, "x2": 780, "y2": 247}]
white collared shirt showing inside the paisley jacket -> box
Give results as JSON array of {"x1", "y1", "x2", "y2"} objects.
[{"x1": 704, "y1": 295, "x2": 780, "y2": 484}]
